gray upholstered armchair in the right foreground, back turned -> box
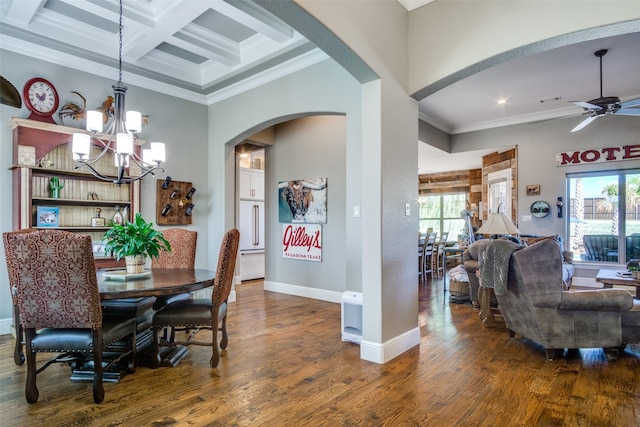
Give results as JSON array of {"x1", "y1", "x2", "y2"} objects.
[{"x1": 496, "y1": 240, "x2": 640, "y2": 359}]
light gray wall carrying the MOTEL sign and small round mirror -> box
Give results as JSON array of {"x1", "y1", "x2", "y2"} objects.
[{"x1": 451, "y1": 115, "x2": 640, "y2": 244}]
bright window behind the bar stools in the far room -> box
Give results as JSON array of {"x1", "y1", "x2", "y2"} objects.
[{"x1": 419, "y1": 193, "x2": 467, "y2": 240}]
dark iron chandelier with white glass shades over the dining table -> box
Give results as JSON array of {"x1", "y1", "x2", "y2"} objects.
[{"x1": 72, "y1": 0, "x2": 165, "y2": 185}]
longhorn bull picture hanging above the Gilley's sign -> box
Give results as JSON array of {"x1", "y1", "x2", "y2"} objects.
[{"x1": 278, "y1": 178, "x2": 327, "y2": 224}]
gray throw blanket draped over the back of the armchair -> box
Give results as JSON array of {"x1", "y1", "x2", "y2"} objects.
[{"x1": 478, "y1": 240, "x2": 521, "y2": 295}]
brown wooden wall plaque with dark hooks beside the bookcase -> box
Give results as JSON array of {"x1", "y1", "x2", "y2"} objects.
[{"x1": 156, "y1": 177, "x2": 196, "y2": 225}]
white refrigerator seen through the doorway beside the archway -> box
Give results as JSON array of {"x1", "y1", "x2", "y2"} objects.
[{"x1": 239, "y1": 200, "x2": 264, "y2": 280}]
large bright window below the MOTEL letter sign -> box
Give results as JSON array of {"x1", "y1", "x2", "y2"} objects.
[{"x1": 567, "y1": 169, "x2": 640, "y2": 264}]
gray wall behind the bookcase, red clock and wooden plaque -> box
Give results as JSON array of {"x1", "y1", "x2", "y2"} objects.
[{"x1": 0, "y1": 50, "x2": 209, "y2": 320}]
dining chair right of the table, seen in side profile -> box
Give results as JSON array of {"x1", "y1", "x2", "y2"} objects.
[{"x1": 151, "y1": 228, "x2": 240, "y2": 368}]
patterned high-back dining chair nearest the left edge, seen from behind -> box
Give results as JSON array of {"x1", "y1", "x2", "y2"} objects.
[{"x1": 3, "y1": 230, "x2": 135, "y2": 403}]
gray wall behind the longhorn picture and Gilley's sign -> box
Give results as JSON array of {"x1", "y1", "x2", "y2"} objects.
[{"x1": 265, "y1": 116, "x2": 344, "y2": 294}]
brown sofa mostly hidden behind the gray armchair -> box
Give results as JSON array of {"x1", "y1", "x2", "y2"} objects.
[{"x1": 462, "y1": 235, "x2": 575, "y2": 307}]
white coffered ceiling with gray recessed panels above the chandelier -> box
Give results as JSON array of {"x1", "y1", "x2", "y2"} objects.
[{"x1": 0, "y1": 0, "x2": 327, "y2": 104}]
